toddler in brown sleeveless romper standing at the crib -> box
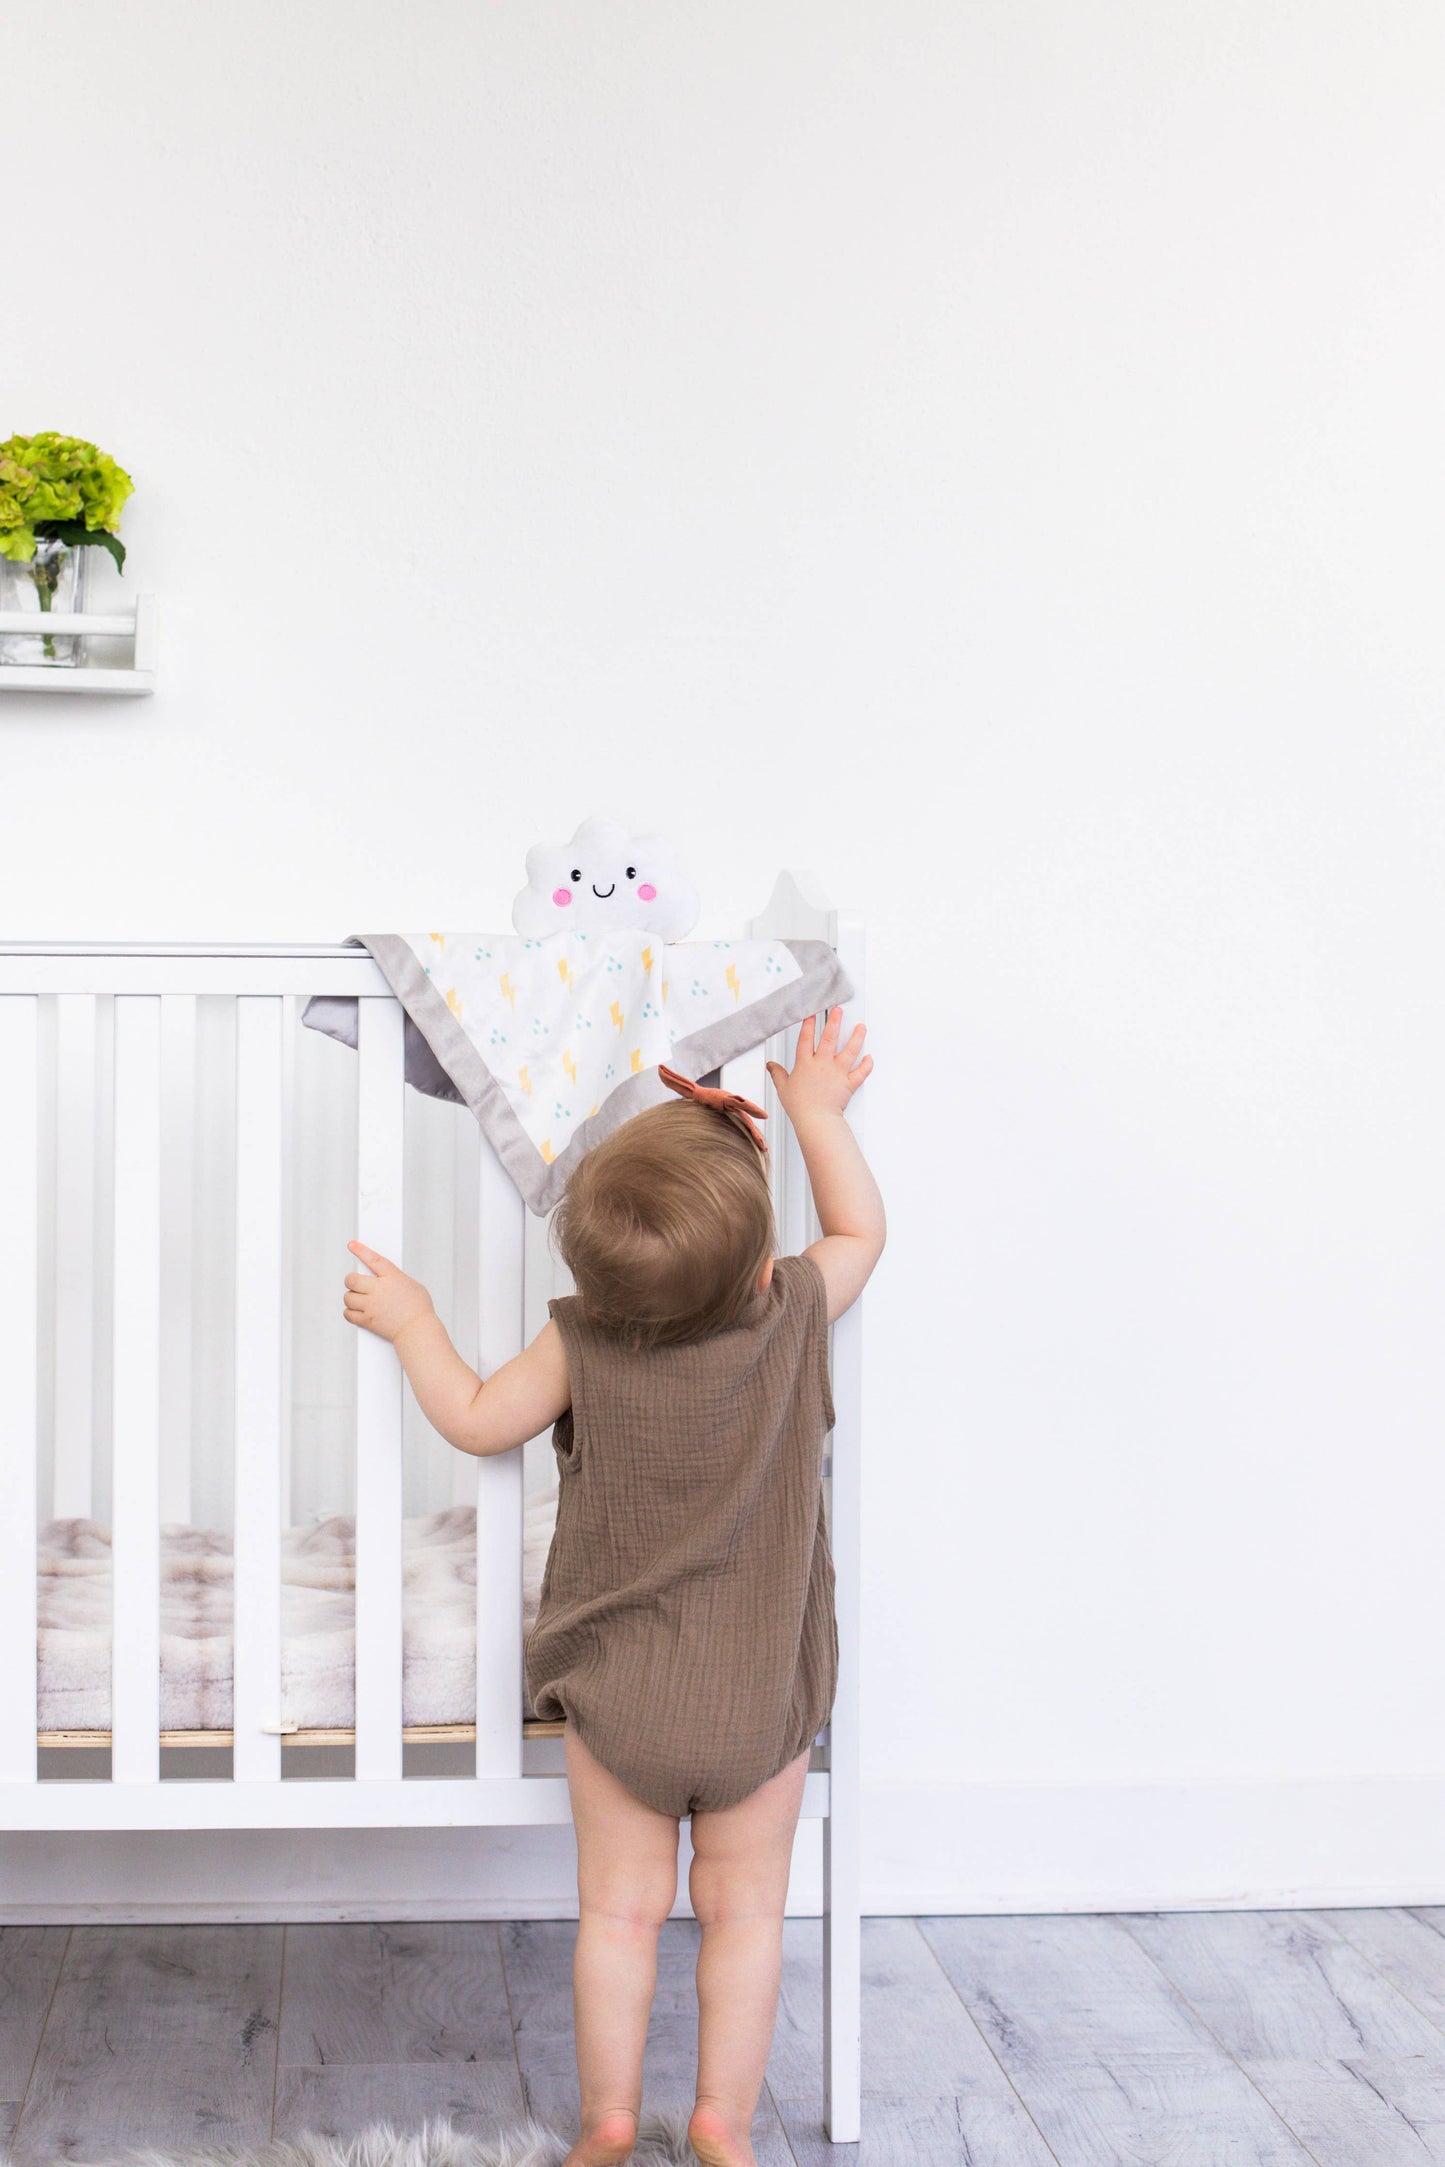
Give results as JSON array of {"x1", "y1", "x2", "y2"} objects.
[{"x1": 347, "y1": 1008, "x2": 884, "y2": 2167}]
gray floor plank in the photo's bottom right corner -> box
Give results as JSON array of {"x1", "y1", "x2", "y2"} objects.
[{"x1": 1246, "y1": 2054, "x2": 1445, "y2": 2167}]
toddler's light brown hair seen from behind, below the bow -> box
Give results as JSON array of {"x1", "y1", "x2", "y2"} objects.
[{"x1": 552, "y1": 1101, "x2": 773, "y2": 1348}]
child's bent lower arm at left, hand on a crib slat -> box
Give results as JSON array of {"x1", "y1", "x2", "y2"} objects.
[{"x1": 347, "y1": 1242, "x2": 572, "y2": 1454}]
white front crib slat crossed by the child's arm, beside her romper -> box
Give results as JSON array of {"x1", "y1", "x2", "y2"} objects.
[{"x1": 477, "y1": 1142, "x2": 526, "y2": 1777}]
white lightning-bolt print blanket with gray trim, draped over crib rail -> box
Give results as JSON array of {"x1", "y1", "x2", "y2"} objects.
[{"x1": 303, "y1": 927, "x2": 851, "y2": 1214}]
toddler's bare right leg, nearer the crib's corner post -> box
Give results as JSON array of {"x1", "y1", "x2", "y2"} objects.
[{"x1": 687, "y1": 1753, "x2": 808, "y2": 2167}]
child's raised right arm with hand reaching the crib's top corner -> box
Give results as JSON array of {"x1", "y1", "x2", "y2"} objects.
[{"x1": 767, "y1": 1008, "x2": 888, "y2": 1324}]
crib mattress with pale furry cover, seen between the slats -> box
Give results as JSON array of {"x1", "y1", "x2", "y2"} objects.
[{"x1": 39, "y1": 1493, "x2": 557, "y2": 1734}]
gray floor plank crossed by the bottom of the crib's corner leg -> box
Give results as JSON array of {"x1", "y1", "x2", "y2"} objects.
[{"x1": 767, "y1": 1918, "x2": 1051, "y2": 2167}]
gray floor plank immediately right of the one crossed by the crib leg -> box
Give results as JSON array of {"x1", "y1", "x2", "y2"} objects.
[{"x1": 919, "y1": 1916, "x2": 1309, "y2": 2167}]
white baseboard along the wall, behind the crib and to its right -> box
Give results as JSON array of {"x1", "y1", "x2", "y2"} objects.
[{"x1": 0, "y1": 1775, "x2": 1445, "y2": 1924}]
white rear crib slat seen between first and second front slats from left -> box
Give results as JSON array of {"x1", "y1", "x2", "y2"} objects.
[{"x1": 54, "y1": 992, "x2": 95, "y2": 1519}]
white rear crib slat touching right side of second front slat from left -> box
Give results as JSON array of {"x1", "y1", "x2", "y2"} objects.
[{"x1": 160, "y1": 992, "x2": 195, "y2": 1523}]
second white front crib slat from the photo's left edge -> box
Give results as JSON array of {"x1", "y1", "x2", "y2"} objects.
[{"x1": 110, "y1": 995, "x2": 160, "y2": 1783}]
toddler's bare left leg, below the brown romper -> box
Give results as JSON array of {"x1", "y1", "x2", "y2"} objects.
[{"x1": 563, "y1": 1725, "x2": 678, "y2": 2167}]
